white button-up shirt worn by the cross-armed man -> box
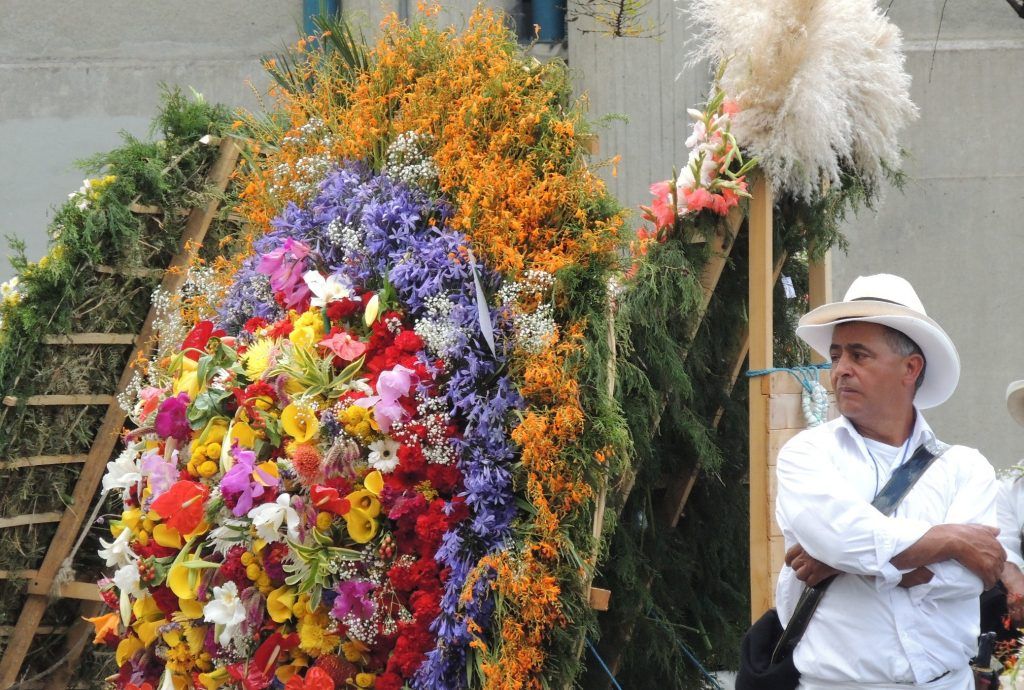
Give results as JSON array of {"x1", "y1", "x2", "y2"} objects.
[{"x1": 775, "y1": 412, "x2": 997, "y2": 690}]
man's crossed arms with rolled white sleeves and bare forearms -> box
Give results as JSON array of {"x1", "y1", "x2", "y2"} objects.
[{"x1": 776, "y1": 442, "x2": 1006, "y2": 596}]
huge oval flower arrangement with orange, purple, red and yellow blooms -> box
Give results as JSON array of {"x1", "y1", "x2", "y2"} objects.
[{"x1": 92, "y1": 13, "x2": 623, "y2": 690}]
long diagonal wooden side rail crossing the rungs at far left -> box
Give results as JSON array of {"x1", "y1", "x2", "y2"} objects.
[{"x1": 0, "y1": 138, "x2": 241, "y2": 688}]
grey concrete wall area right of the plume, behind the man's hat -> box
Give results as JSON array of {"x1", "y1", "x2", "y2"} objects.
[{"x1": 834, "y1": 0, "x2": 1024, "y2": 467}]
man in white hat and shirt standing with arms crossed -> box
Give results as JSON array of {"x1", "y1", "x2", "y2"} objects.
[{"x1": 776, "y1": 274, "x2": 1006, "y2": 690}]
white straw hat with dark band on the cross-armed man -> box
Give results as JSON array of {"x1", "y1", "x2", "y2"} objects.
[{"x1": 797, "y1": 273, "x2": 958, "y2": 405}]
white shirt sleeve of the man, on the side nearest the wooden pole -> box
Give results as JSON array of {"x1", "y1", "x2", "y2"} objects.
[{"x1": 775, "y1": 430, "x2": 931, "y2": 587}]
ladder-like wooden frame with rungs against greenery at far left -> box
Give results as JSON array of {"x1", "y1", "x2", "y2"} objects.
[{"x1": 0, "y1": 137, "x2": 242, "y2": 690}]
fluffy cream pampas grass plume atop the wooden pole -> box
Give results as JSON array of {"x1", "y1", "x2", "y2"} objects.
[{"x1": 688, "y1": 0, "x2": 918, "y2": 198}]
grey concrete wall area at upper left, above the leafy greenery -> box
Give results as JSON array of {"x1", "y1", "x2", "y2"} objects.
[{"x1": 0, "y1": 0, "x2": 302, "y2": 279}]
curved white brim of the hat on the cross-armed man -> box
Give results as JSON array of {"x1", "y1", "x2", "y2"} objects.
[{"x1": 797, "y1": 300, "x2": 958, "y2": 409}]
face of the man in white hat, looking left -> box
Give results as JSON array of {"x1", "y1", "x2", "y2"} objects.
[{"x1": 828, "y1": 321, "x2": 921, "y2": 423}]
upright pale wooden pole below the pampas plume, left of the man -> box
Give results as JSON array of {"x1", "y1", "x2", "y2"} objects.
[{"x1": 748, "y1": 175, "x2": 774, "y2": 620}]
